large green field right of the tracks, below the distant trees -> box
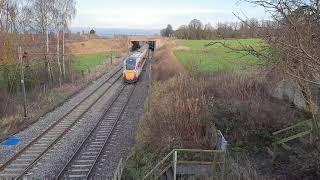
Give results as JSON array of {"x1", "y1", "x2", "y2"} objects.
[{"x1": 174, "y1": 39, "x2": 265, "y2": 72}]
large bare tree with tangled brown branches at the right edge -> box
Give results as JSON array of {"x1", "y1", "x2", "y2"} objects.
[{"x1": 244, "y1": 0, "x2": 320, "y2": 141}]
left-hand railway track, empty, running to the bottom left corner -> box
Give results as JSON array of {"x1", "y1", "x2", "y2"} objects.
[{"x1": 0, "y1": 68, "x2": 122, "y2": 179}]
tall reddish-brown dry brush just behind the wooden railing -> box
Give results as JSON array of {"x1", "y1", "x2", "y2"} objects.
[{"x1": 141, "y1": 75, "x2": 215, "y2": 149}]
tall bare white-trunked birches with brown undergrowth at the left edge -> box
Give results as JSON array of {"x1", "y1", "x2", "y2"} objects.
[{"x1": 0, "y1": 0, "x2": 76, "y2": 115}]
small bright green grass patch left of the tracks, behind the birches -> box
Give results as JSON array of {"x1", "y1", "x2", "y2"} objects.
[{"x1": 73, "y1": 53, "x2": 110, "y2": 71}]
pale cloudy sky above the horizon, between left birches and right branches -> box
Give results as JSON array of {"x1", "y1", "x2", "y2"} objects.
[{"x1": 71, "y1": 0, "x2": 268, "y2": 29}]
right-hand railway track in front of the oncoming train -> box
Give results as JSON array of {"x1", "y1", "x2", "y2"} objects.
[{"x1": 56, "y1": 85, "x2": 135, "y2": 179}]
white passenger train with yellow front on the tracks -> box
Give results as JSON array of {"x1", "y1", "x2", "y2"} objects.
[{"x1": 123, "y1": 44, "x2": 149, "y2": 83}]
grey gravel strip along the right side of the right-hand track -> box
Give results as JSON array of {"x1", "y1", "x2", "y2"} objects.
[{"x1": 94, "y1": 63, "x2": 150, "y2": 179}]
